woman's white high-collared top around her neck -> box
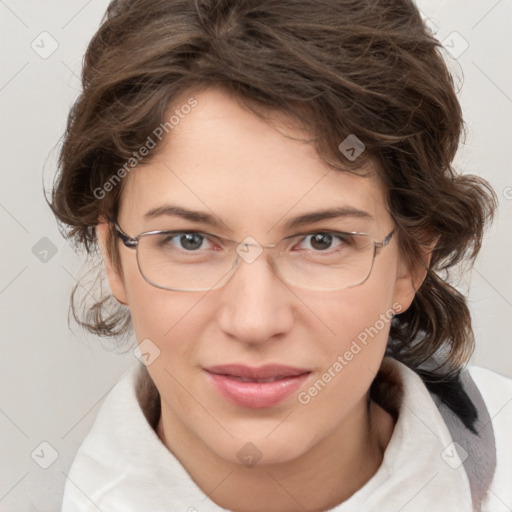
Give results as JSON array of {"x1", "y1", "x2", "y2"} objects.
[{"x1": 61, "y1": 360, "x2": 512, "y2": 512}]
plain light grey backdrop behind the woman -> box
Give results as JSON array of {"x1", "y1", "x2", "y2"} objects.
[{"x1": 0, "y1": 0, "x2": 512, "y2": 512}]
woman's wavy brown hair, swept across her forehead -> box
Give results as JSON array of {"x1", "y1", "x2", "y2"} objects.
[{"x1": 50, "y1": 0, "x2": 496, "y2": 377}]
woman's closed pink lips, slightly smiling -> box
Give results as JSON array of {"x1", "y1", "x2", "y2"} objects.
[{"x1": 205, "y1": 364, "x2": 311, "y2": 409}]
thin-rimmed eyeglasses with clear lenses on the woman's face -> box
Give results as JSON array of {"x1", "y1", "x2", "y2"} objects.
[{"x1": 111, "y1": 220, "x2": 395, "y2": 291}]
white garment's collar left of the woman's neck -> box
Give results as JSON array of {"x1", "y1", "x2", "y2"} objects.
[{"x1": 61, "y1": 362, "x2": 203, "y2": 512}]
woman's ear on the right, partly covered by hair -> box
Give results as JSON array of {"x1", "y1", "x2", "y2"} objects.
[{"x1": 393, "y1": 242, "x2": 435, "y2": 314}]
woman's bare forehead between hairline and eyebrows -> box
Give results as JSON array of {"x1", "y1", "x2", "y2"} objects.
[{"x1": 120, "y1": 89, "x2": 388, "y2": 232}]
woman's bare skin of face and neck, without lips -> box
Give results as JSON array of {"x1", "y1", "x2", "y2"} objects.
[{"x1": 97, "y1": 89, "x2": 426, "y2": 512}]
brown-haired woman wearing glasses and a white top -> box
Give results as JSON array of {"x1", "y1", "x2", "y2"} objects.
[{"x1": 52, "y1": 0, "x2": 511, "y2": 512}]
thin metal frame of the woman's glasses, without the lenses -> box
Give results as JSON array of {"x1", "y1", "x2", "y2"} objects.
[{"x1": 108, "y1": 219, "x2": 396, "y2": 292}]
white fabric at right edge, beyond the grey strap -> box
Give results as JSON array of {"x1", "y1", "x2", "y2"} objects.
[{"x1": 468, "y1": 366, "x2": 512, "y2": 512}]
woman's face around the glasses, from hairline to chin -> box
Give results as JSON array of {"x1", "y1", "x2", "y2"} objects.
[{"x1": 99, "y1": 89, "x2": 414, "y2": 463}]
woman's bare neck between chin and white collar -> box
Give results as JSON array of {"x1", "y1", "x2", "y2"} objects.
[{"x1": 157, "y1": 400, "x2": 394, "y2": 512}]
